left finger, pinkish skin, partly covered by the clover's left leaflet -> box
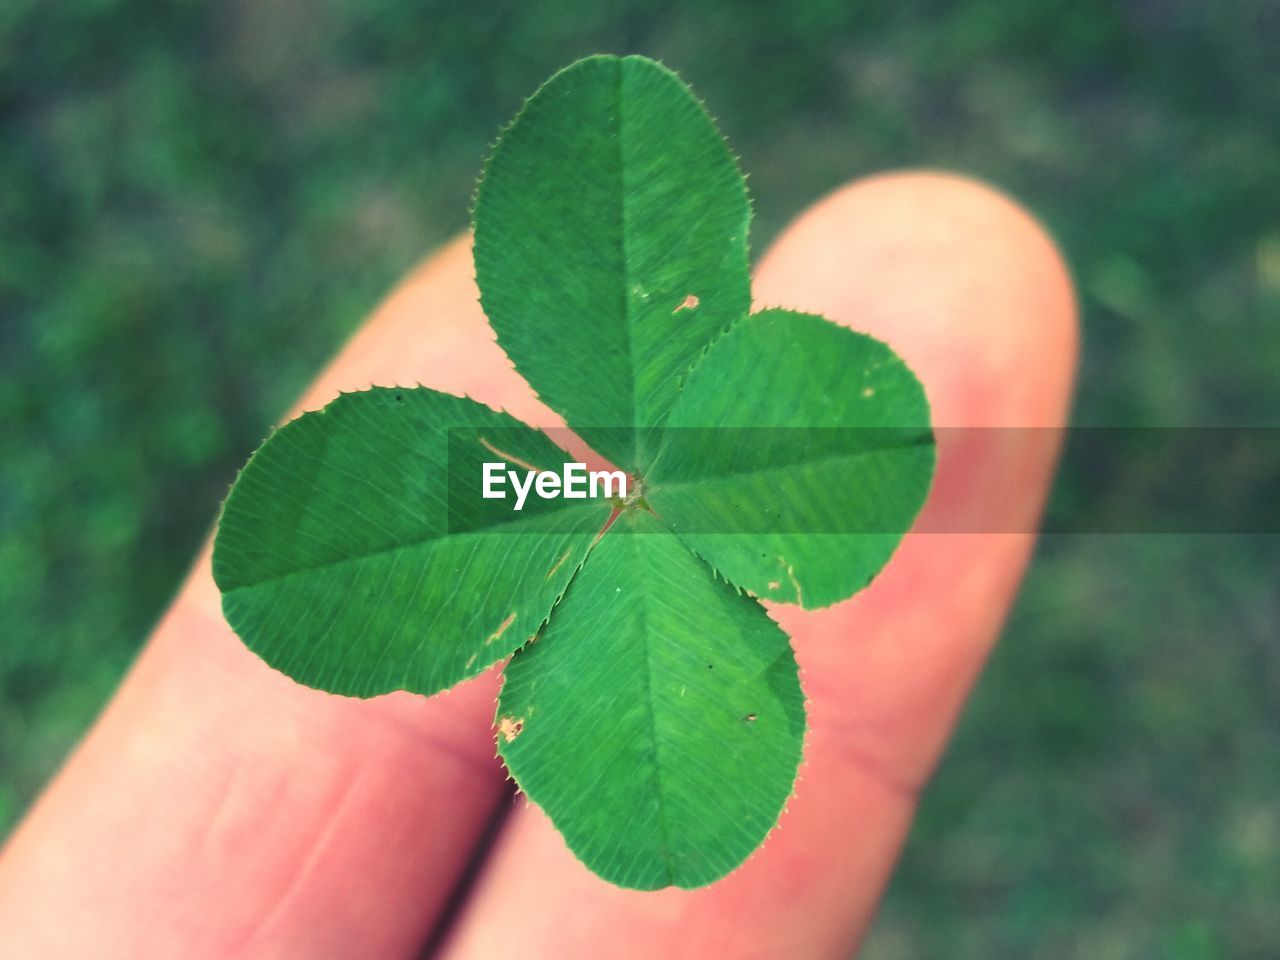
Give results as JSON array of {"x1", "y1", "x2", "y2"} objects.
[{"x1": 0, "y1": 241, "x2": 545, "y2": 957}]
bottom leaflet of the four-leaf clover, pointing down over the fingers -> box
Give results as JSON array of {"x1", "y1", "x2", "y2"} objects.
[{"x1": 498, "y1": 511, "x2": 804, "y2": 890}]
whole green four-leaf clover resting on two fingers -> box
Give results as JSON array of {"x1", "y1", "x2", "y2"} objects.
[{"x1": 214, "y1": 56, "x2": 933, "y2": 888}]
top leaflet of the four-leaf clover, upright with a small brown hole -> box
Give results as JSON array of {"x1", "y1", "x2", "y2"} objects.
[{"x1": 475, "y1": 56, "x2": 751, "y2": 470}]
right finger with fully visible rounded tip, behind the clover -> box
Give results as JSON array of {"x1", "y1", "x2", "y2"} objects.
[{"x1": 445, "y1": 173, "x2": 1075, "y2": 959}]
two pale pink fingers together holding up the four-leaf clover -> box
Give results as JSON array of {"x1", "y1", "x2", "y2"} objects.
[{"x1": 0, "y1": 173, "x2": 1076, "y2": 960}]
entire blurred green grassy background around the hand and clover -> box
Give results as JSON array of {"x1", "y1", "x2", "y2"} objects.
[{"x1": 0, "y1": 0, "x2": 1280, "y2": 960}]
